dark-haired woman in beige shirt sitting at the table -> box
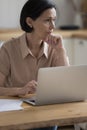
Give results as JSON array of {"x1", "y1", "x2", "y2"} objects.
[{"x1": 0, "y1": 0, "x2": 69, "y2": 130}]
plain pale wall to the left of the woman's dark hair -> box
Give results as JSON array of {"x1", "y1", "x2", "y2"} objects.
[{"x1": 0, "y1": 0, "x2": 26, "y2": 28}]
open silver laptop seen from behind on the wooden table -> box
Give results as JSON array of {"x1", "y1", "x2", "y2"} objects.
[{"x1": 23, "y1": 65, "x2": 87, "y2": 105}]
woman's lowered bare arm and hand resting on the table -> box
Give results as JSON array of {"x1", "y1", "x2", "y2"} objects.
[{"x1": 0, "y1": 72, "x2": 37, "y2": 96}]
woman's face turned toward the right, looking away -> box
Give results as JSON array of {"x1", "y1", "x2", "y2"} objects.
[{"x1": 32, "y1": 8, "x2": 56, "y2": 40}]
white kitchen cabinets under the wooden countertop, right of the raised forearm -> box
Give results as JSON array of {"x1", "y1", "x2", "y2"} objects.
[{"x1": 63, "y1": 38, "x2": 87, "y2": 65}]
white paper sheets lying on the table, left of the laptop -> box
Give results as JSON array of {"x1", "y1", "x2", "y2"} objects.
[{"x1": 0, "y1": 99, "x2": 23, "y2": 112}]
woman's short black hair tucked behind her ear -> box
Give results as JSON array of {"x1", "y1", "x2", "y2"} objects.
[{"x1": 20, "y1": 0, "x2": 56, "y2": 32}]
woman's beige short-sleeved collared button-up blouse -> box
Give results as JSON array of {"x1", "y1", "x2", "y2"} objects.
[{"x1": 0, "y1": 33, "x2": 69, "y2": 87}]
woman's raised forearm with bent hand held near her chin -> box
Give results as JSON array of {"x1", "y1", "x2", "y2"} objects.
[{"x1": 46, "y1": 34, "x2": 69, "y2": 66}]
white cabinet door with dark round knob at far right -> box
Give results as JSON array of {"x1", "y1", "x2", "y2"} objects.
[{"x1": 73, "y1": 38, "x2": 87, "y2": 65}]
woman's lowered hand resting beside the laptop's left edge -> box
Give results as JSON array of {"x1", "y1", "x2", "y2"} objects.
[{"x1": 20, "y1": 80, "x2": 37, "y2": 95}]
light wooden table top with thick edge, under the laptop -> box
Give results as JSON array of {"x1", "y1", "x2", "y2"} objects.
[{"x1": 0, "y1": 96, "x2": 87, "y2": 130}]
